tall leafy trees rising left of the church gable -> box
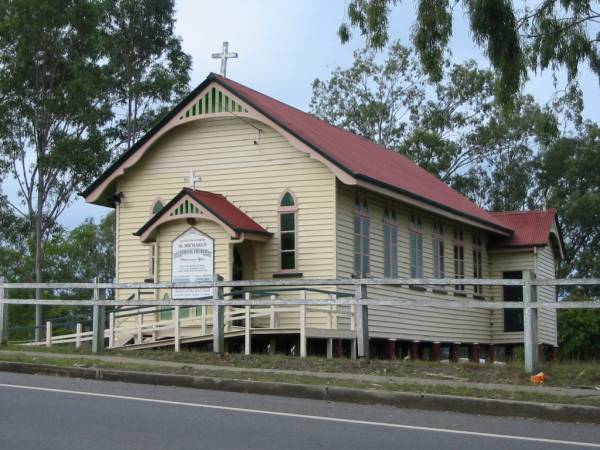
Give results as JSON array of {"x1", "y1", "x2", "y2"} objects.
[{"x1": 0, "y1": 0, "x2": 190, "y2": 334}]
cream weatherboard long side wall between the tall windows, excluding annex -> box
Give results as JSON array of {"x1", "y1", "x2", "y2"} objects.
[{"x1": 336, "y1": 184, "x2": 492, "y2": 343}]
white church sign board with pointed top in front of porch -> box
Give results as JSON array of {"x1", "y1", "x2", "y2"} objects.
[{"x1": 171, "y1": 228, "x2": 215, "y2": 300}]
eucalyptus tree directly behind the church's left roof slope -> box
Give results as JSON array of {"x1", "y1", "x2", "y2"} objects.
[{"x1": 105, "y1": 0, "x2": 191, "y2": 149}]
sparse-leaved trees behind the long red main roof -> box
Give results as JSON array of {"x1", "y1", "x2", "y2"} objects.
[{"x1": 311, "y1": 43, "x2": 558, "y2": 210}]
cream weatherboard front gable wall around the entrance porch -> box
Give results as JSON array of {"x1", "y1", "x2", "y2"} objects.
[{"x1": 112, "y1": 117, "x2": 336, "y2": 326}]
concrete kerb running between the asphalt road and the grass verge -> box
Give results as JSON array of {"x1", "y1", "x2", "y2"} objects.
[{"x1": 0, "y1": 361, "x2": 600, "y2": 424}]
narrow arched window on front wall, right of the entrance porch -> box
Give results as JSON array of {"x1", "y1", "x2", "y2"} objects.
[{"x1": 277, "y1": 191, "x2": 298, "y2": 271}]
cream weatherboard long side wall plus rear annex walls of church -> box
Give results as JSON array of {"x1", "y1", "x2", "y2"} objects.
[{"x1": 336, "y1": 183, "x2": 556, "y2": 345}]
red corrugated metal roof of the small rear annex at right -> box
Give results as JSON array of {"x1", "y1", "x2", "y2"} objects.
[{"x1": 492, "y1": 208, "x2": 560, "y2": 247}]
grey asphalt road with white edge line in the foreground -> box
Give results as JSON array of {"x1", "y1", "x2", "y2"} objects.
[{"x1": 0, "y1": 373, "x2": 600, "y2": 450}]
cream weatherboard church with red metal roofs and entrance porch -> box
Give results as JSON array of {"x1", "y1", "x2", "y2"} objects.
[{"x1": 81, "y1": 74, "x2": 564, "y2": 360}]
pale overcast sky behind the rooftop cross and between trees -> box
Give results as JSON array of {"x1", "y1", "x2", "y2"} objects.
[{"x1": 10, "y1": 0, "x2": 600, "y2": 228}]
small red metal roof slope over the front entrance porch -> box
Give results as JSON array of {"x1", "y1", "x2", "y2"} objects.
[{"x1": 183, "y1": 188, "x2": 271, "y2": 234}]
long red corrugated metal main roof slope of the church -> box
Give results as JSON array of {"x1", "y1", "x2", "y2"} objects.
[{"x1": 216, "y1": 74, "x2": 510, "y2": 231}]
